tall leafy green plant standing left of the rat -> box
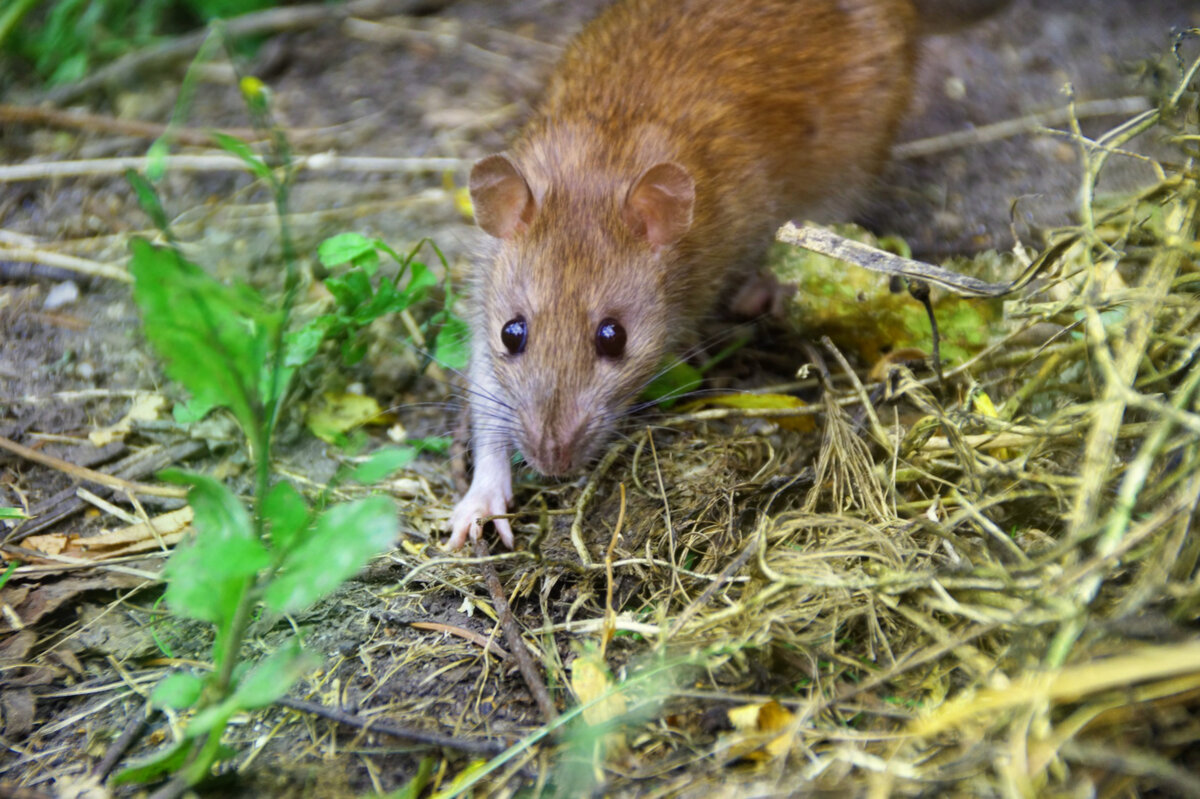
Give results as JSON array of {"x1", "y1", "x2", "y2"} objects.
[{"x1": 115, "y1": 82, "x2": 412, "y2": 785}]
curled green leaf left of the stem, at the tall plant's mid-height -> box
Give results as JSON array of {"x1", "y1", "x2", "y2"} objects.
[{"x1": 160, "y1": 471, "x2": 269, "y2": 624}]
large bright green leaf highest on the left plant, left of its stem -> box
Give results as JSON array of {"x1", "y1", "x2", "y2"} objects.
[{"x1": 130, "y1": 239, "x2": 280, "y2": 433}]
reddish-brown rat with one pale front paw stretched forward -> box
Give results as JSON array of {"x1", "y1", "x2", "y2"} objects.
[{"x1": 448, "y1": 0, "x2": 1004, "y2": 548}]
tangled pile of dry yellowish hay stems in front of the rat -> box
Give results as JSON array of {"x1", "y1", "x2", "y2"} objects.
[{"x1": 374, "y1": 48, "x2": 1200, "y2": 795}]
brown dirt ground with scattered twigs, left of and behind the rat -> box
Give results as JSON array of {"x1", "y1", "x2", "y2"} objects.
[{"x1": 0, "y1": 0, "x2": 1200, "y2": 797}]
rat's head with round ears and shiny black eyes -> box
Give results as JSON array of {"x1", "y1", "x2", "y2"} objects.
[{"x1": 470, "y1": 155, "x2": 695, "y2": 475}]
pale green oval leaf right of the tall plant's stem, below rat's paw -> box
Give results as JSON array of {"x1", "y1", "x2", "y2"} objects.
[{"x1": 264, "y1": 497, "x2": 400, "y2": 613}]
